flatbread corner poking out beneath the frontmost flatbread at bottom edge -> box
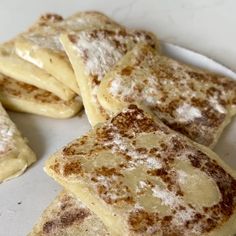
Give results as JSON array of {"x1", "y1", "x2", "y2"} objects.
[{"x1": 29, "y1": 191, "x2": 109, "y2": 236}]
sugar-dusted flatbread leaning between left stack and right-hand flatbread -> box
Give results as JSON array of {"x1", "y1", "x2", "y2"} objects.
[{"x1": 61, "y1": 29, "x2": 159, "y2": 125}]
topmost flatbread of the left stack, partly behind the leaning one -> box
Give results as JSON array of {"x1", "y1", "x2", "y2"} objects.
[{"x1": 15, "y1": 12, "x2": 123, "y2": 93}]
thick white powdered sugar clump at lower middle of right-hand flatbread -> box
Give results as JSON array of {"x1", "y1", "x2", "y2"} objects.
[{"x1": 176, "y1": 103, "x2": 202, "y2": 122}]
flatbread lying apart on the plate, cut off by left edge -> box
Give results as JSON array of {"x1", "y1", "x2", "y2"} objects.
[{"x1": 0, "y1": 103, "x2": 36, "y2": 183}]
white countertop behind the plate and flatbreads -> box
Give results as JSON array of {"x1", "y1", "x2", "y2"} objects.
[{"x1": 0, "y1": 0, "x2": 236, "y2": 71}]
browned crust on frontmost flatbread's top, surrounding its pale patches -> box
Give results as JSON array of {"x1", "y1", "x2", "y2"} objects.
[{"x1": 49, "y1": 105, "x2": 236, "y2": 235}]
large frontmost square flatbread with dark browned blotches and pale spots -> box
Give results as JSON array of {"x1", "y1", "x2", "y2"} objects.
[{"x1": 45, "y1": 105, "x2": 236, "y2": 236}]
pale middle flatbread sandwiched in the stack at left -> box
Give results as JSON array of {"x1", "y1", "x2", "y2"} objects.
[{"x1": 0, "y1": 41, "x2": 75, "y2": 101}]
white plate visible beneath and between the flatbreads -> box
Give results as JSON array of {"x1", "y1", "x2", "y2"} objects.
[{"x1": 0, "y1": 41, "x2": 236, "y2": 236}]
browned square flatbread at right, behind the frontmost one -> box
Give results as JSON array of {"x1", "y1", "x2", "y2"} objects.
[{"x1": 98, "y1": 45, "x2": 236, "y2": 147}]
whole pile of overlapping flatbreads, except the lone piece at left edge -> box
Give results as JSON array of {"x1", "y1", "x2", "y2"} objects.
[{"x1": 0, "y1": 12, "x2": 236, "y2": 236}]
